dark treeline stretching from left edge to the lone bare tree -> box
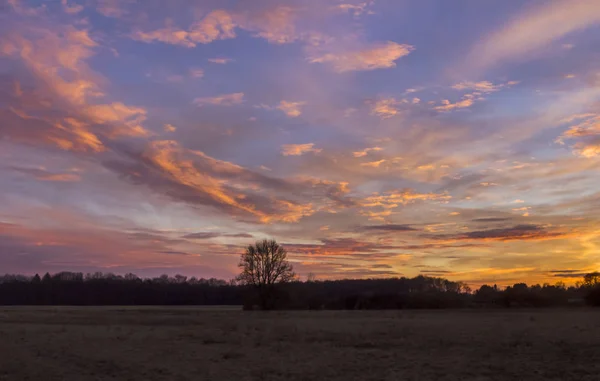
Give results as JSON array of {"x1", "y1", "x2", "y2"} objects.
[{"x1": 0, "y1": 272, "x2": 242, "y2": 306}]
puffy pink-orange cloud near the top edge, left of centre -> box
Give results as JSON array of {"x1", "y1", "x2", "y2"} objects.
[{"x1": 131, "y1": 10, "x2": 236, "y2": 48}]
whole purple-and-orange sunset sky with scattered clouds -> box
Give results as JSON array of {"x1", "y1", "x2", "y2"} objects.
[{"x1": 0, "y1": 0, "x2": 600, "y2": 285}]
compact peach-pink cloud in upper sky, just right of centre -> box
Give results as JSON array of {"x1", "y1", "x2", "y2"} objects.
[{"x1": 309, "y1": 41, "x2": 414, "y2": 73}]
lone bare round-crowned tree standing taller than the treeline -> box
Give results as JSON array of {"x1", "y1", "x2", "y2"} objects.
[{"x1": 237, "y1": 239, "x2": 296, "y2": 310}]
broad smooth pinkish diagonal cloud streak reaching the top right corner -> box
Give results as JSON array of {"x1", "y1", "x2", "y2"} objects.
[{"x1": 466, "y1": 0, "x2": 600, "y2": 70}]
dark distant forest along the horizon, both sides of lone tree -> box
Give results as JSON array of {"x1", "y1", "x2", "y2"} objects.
[{"x1": 0, "y1": 272, "x2": 600, "y2": 310}]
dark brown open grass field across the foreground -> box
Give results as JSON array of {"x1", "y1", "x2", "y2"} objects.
[{"x1": 0, "y1": 307, "x2": 600, "y2": 381}]
